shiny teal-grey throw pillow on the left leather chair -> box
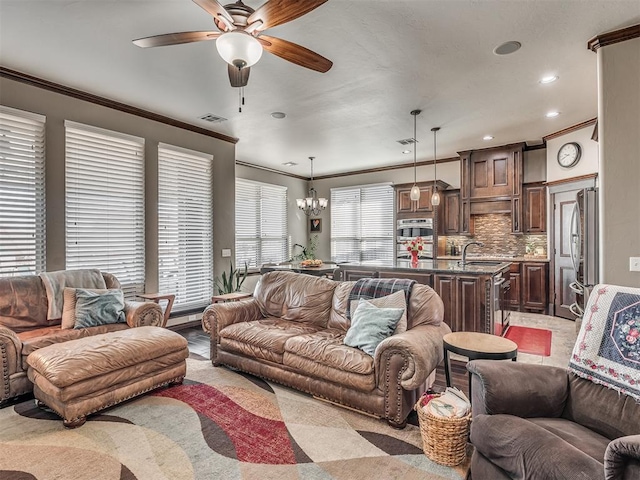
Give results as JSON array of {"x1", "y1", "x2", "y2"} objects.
[{"x1": 73, "y1": 288, "x2": 125, "y2": 329}]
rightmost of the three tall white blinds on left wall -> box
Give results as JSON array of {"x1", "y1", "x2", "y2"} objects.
[{"x1": 158, "y1": 144, "x2": 213, "y2": 312}]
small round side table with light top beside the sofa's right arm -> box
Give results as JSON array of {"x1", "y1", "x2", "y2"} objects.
[{"x1": 442, "y1": 332, "x2": 518, "y2": 400}]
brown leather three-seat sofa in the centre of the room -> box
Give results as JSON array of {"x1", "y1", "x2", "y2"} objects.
[{"x1": 202, "y1": 272, "x2": 450, "y2": 428}]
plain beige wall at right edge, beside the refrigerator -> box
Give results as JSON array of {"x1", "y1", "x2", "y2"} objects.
[{"x1": 597, "y1": 38, "x2": 640, "y2": 287}]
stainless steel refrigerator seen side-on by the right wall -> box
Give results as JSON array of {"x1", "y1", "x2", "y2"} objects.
[{"x1": 569, "y1": 188, "x2": 599, "y2": 319}]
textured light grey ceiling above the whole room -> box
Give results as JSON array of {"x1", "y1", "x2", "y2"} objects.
[{"x1": 0, "y1": 0, "x2": 640, "y2": 175}]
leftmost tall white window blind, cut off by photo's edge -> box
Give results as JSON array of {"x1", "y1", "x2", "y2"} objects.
[{"x1": 0, "y1": 106, "x2": 45, "y2": 276}]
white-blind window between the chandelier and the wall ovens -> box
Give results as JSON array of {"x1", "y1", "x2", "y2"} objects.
[{"x1": 330, "y1": 185, "x2": 395, "y2": 262}]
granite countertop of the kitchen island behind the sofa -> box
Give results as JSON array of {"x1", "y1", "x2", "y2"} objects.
[{"x1": 339, "y1": 259, "x2": 511, "y2": 275}]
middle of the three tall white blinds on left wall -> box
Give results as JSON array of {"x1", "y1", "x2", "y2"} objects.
[{"x1": 65, "y1": 121, "x2": 145, "y2": 300}]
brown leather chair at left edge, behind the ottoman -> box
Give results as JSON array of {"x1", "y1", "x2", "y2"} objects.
[{"x1": 0, "y1": 272, "x2": 163, "y2": 406}]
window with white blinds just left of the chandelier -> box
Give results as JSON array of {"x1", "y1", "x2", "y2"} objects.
[{"x1": 236, "y1": 179, "x2": 289, "y2": 268}]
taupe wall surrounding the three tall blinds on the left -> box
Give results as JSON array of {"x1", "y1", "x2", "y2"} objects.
[{"x1": 0, "y1": 78, "x2": 235, "y2": 292}]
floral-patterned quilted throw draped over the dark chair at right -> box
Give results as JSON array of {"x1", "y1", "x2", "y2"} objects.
[{"x1": 569, "y1": 284, "x2": 640, "y2": 402}]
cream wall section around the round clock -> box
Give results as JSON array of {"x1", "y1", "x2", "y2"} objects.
[{"x1": 547, "y1": 125, "x2": 599, "y2": 182}]
